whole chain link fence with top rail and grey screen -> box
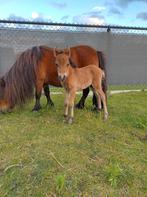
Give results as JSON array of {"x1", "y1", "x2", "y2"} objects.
[{"x1": 0, "y1": 20, "x2": 147, "y2": 89}]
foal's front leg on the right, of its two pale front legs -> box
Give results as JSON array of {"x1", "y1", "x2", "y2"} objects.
[{"x1": 68, "y1": 91, "x2": 76, "y2": 124}]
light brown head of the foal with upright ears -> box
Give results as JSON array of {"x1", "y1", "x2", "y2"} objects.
[{"x1": 54, "y1": 49, "x2": 70, "y2": 82}]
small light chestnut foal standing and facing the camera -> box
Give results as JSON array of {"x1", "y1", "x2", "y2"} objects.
[{"x1": 54, "y1": 49, "x2": 108, "y2": 124}]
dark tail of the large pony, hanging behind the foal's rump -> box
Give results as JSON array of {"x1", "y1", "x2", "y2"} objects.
[{"x1": 97, "y1": 51, "x2": 107, "y2": 94}]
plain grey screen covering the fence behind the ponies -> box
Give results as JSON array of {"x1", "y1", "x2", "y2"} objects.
[{"x1": 0, "y1": 28, "x2": 147, "y2": 85}]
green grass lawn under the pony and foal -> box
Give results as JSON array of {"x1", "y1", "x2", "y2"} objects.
[{"x1": 0, "y1": 92, "x2": 147, "y2": 197}]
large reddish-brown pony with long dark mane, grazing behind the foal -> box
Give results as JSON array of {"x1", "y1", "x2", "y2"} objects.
[{"x1": 0, "y1": 45, "x2": 106, "y2": 111}]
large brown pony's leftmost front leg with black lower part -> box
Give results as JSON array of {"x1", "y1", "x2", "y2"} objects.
[{"x1": 32, "y1": 81, "x2": 43, "y2": 111}]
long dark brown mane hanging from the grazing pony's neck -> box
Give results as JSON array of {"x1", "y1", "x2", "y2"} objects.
[{"x1": 5, "y1": 47, "x2": 42, "y2": 107}]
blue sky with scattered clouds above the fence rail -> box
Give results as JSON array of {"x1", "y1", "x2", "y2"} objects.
[{"x1": 0, "y1": 0, "x2": 147, "y2": 27}]
